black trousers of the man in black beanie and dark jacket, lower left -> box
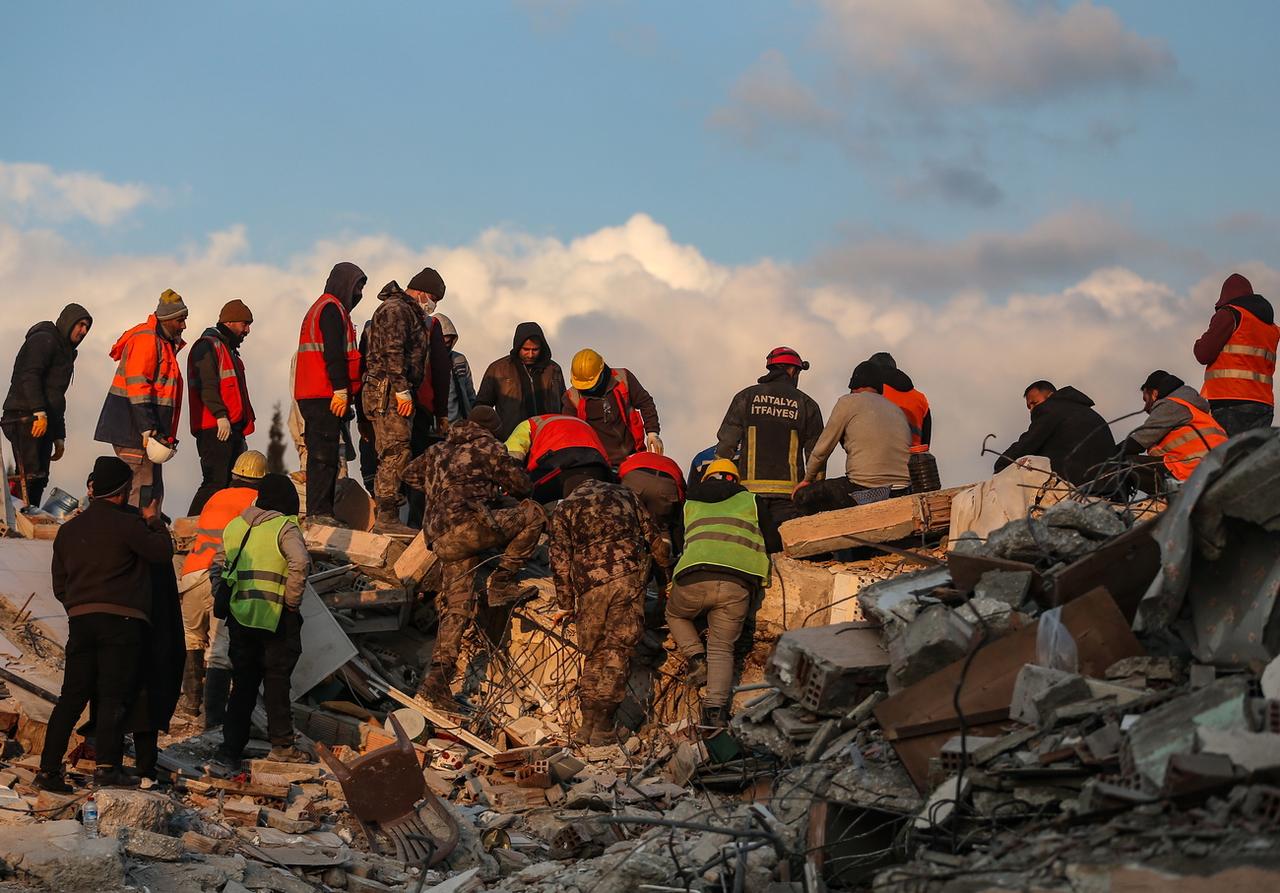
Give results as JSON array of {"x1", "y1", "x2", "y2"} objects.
[{"x1": 40, "y1": 614, "x2": 147, "y2": 773}]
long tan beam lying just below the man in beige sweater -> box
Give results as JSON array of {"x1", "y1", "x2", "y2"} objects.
[{"x1": 778, "y1": 487, "x2": 966, "y2": 558}]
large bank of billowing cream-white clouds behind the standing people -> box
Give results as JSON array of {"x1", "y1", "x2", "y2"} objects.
[{"x1": 0, "y1": 215, "x2": 1259, "y2": 513}]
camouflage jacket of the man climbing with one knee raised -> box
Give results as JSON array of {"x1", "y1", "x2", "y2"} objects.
[{"x1": 403, "y1": 421, "x2": 534, "y2": 542}]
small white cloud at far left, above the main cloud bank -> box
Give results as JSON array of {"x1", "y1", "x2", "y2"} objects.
[{"x1": 0, "y1": 161, "x2": 154, "y2": 226}]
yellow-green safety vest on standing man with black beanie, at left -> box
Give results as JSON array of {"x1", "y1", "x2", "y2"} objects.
[{"x1": 223, "y1": 516, "x2": 297, "y2": 632}]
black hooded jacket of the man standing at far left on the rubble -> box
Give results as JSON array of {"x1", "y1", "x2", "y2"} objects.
[{"x1": 4, "y1": 304, "x2": 93, "y2": 440}]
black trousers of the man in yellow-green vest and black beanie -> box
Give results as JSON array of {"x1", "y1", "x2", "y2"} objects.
[{"x1": 223, "y1": 608, "x2": 310, "y2": 757}]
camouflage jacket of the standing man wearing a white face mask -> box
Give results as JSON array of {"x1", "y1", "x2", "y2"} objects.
[{"x1": 364, "y1": 281, "x2": 431, "y2": 413}]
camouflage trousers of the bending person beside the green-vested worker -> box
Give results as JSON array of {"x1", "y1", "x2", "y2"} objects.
[{"x1": 577, "y1": 573, "x2": 645, "y2": 704}]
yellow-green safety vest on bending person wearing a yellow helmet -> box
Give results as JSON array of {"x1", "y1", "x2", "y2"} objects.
[{"x1": 675, "y1": 491, "x2": 769, "y2": 580}]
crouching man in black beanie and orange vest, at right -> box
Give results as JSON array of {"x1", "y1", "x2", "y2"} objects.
[{"x1": 1120, "y1": 370, "x2": 1228, "y2": 496}]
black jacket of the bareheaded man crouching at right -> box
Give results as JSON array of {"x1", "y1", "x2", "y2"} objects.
[{"x1": 996, "y1": 386, "x2": 1116, "y2": 486}]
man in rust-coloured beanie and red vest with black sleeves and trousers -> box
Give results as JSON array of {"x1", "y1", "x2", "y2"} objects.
[{"x1": 187, "y1": 298, "x2": 255, "y2": 516}]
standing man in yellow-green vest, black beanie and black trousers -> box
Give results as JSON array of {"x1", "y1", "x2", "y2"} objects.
[{"x1": 210, "y1": 473, "x2": 311, "y2": 768}]
